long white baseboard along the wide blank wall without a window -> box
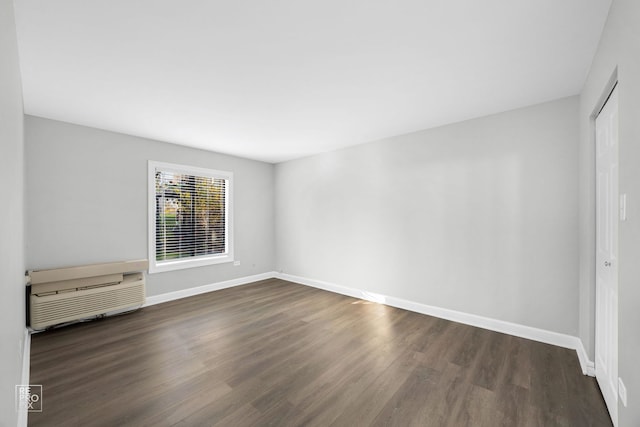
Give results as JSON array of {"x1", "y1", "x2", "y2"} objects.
[{"x1": 276, "y1": 273, "x2": 595, "y2": 376}]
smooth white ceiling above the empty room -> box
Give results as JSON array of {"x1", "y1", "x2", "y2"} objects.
[{"x1": 15, "y1": 0, "x2": 611, "y2": 162}]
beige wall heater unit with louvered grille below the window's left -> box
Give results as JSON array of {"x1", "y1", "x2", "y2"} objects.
[{"x1": 27, "y1": 260, "x2": 148, "y2": 329}]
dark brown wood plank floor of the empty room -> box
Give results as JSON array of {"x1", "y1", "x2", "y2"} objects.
[{"x1": 29, "y1": 279, "x2": 611, "y2": 427}]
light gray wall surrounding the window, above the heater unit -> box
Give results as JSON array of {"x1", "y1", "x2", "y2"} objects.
[{"x1": 25, "y1": 116, "x2": 275, "y2": 296}]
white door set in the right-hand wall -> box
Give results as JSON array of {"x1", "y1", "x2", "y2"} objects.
[{"x1": 595, "y1": 83, "x2": 618, "y2": 425}]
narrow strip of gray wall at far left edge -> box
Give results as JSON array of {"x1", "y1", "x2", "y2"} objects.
[{"x1": 0, "y1": 0, "x2": 25, "y2": 426}]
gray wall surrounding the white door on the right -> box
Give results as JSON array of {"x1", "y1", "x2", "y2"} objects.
[{"x1": 580, "y1": 0, "x2": 640, "y2": 426}]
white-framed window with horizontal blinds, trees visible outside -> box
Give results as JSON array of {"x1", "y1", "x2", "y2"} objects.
[{"x1": 149, "y1": 161, "x2": 233, "y2": 273}]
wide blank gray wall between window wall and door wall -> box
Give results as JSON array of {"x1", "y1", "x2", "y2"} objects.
[{"x1": 276, "y1": 97, "x2": 578, "y2": 335}]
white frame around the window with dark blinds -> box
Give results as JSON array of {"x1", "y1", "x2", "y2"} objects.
[{"x1": 147, "y1": 160, "x2": 233, "y2": 274}]
